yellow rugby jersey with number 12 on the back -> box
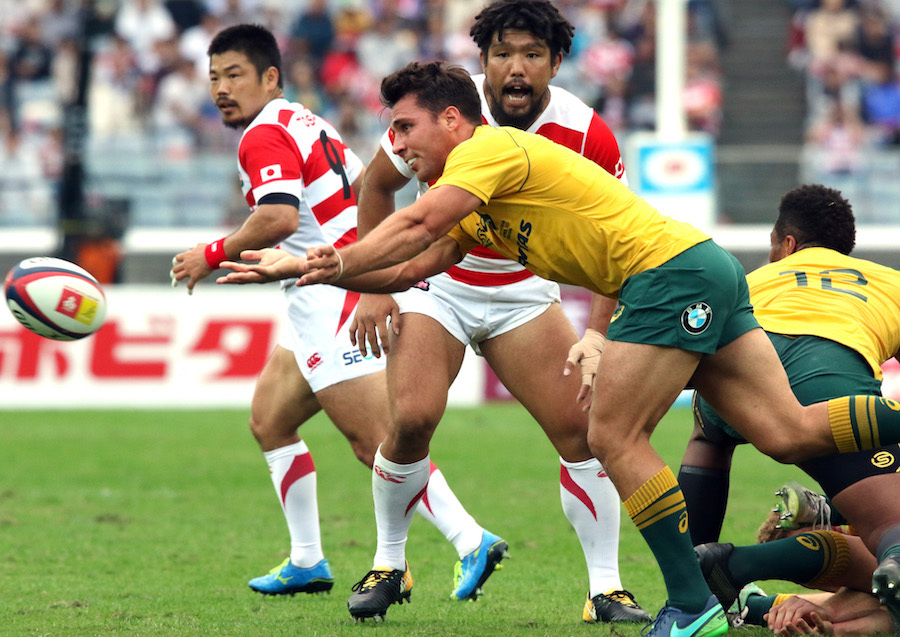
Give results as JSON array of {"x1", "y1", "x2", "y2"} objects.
[{"x1": 747, "y1": 248, "x2": 900, "y2": 379}]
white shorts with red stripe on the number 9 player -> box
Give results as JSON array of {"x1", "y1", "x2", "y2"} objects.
[{"x1": 278, "y1": 281, "x2": 385, "y2": 392}]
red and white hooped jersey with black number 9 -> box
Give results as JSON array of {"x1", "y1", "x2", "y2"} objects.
[{"x1": 238, "y1": 99, "x2": 363, "y2": 256}]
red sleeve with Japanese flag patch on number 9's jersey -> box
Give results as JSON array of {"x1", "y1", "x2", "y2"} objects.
[{"x1": 238, "y1": 125, "x2": 303, "y2": 202}]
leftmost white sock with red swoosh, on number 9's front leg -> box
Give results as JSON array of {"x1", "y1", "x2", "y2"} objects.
[{"x1": 263, "y1": 440, "x2": 325, "y2": 568}]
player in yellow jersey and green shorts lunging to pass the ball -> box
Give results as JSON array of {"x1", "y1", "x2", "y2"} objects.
[{"x1": 220, "y1": 62, "x2": 900, "y2": 636}]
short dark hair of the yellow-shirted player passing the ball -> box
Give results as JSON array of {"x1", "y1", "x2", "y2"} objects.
[{"x1": 381, "y1": 61, "x2": 482, "y2": 125}]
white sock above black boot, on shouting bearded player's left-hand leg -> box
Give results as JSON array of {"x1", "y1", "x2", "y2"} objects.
[{"x1": 372, "y1": 445, "x2": 431, "y2": 571}]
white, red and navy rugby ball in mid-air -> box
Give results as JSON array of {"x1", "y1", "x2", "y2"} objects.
[{"x1": 4, "y1": 257, "x2": 106, "y2": 341}]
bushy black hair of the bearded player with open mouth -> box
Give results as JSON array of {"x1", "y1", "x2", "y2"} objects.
[{"x1": 469, "y1": 0, "x2": 575, "y2": 57}]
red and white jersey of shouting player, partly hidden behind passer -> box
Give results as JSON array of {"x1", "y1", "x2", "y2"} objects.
[{"x1": 381, "y1": 74, "x2": 628, "y2": 286}]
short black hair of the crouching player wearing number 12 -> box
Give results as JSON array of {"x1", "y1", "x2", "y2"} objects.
[{"x1": 775, "y1": 184, "x2": 856, "y2": 254}]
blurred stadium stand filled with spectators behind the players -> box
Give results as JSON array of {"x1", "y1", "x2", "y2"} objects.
[{"x1": 0, "y1": 0, "x2": 900, "y2": 282}]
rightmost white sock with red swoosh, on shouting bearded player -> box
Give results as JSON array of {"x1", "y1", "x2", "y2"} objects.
[{"x1": 559, "y1": 458, "x2": 622, "y2": 597}]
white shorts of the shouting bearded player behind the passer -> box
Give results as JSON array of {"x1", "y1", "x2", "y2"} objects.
[{"x1": 393, "y1": 273, "x2": 559, "y2": 356}]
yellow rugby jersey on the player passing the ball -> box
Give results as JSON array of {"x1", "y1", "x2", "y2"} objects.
[{"x1": 433, "y1": 126, "x2": 709, "y2": 297}]
